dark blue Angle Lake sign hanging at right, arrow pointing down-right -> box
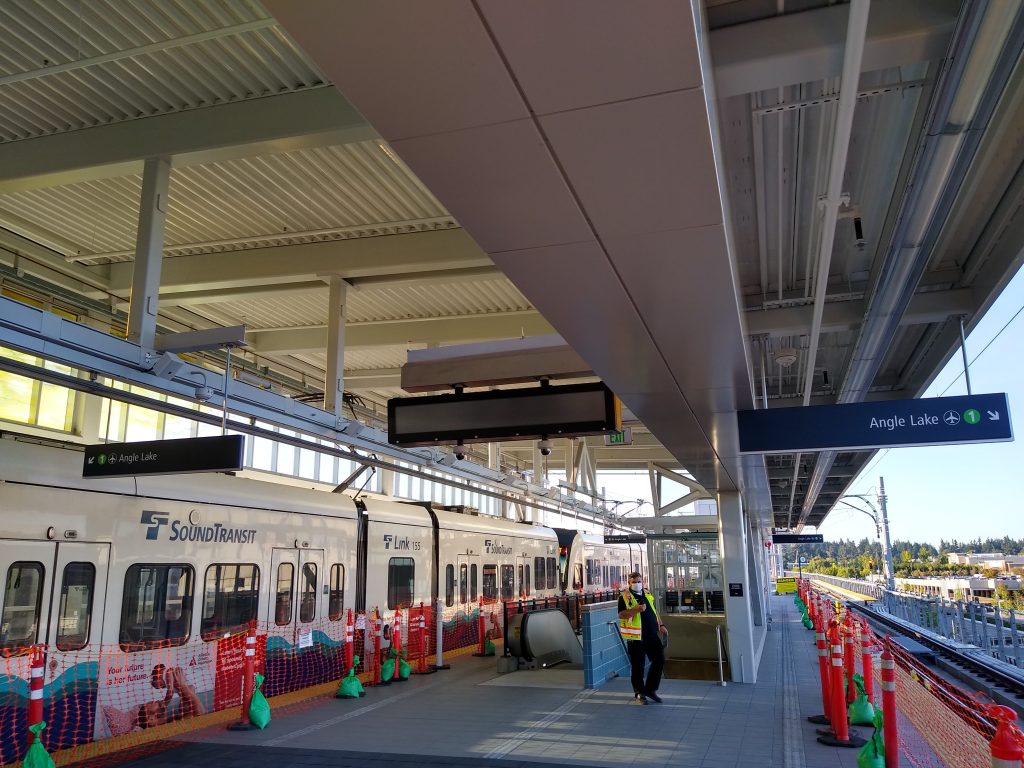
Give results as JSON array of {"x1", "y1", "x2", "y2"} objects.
[{"x1": 736, "y1": 392, "x2": 1014, "y2": 454}]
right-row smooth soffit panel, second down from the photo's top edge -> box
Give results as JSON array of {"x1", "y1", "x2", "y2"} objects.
[{"x1": 541, "y1": 89, "x2": 722, "y2": 237}]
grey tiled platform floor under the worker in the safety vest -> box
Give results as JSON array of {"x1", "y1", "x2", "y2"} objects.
[{"x1": 117, "y1": 596, "x2": 888, "y2": 768}]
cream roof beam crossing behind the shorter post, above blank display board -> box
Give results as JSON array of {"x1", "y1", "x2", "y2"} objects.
[{"x1": 246, "y1": 309, "x2": 554, "y2": 354}]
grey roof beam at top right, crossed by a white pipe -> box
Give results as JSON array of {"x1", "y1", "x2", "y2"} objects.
[{"x1": 710, "y1": 0, "x2": 959, "y2": 98}]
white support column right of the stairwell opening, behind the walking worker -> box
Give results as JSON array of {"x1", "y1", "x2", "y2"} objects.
[{"x1": 718, "y1": 492, "x2": 757, "y2": 683}]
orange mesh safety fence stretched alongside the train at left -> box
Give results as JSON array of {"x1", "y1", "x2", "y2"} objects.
[{"x1": 0, "y1": 601, "x2": 504, "y2": 766}]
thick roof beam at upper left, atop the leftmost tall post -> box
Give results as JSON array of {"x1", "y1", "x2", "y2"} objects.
[{"x1": 0, "y1": 86, "x2": 378, "y2": 194}]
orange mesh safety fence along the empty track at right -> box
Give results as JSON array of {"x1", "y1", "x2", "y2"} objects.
[{"x1": 807, "y1": 588, "x2": 1024, "y2": 768}]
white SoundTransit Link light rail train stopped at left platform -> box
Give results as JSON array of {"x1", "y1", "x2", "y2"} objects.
[{"x1": 0, "y1": 439, "x2": 644, "y2": 763}]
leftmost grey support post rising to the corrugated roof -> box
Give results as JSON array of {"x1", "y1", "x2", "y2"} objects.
[{"x1": 128, "y1": 158, "x2": 171, "y2": 349}]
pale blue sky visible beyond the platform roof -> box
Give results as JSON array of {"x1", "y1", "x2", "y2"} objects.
[{"x1": 598, "y1": 270, "x2": 1024, "y2": 547}]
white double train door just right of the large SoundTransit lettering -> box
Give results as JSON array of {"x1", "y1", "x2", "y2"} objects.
[{"x1": 270, "y1": 549, "x2": 327, "y2": 646}]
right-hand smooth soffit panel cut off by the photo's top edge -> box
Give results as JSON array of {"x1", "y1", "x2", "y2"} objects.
[{"x1": 479, "y1": 0, "x2": 701, "y2": 115}]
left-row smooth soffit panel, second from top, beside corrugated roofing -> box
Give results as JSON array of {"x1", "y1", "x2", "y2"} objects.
[{"x1": 392, "y1": 120, "x2": 593, "y2": 254}]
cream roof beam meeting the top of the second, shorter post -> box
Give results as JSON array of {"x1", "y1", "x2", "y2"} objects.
[{"x1": 111, "y1": 229, "x2": 494, "y2": 294}]
